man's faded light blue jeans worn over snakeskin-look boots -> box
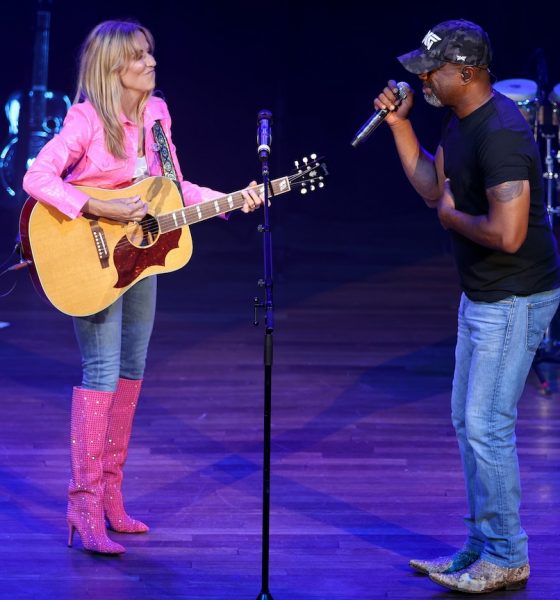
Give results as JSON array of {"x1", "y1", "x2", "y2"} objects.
[{"x1": 451, "y1": 290, "x2": 560, "y2": 567}]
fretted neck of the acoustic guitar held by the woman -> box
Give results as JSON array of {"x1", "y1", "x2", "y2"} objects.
[{"x1": 157, "y1": 177, "x2": 290, "y2": 233}]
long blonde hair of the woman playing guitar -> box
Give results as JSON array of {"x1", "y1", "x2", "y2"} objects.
[{"x1": 74, "y1": 21, "x2": 154, "y2": 158}]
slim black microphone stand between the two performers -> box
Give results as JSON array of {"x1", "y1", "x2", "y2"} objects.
[{"x1": 253, "y1": 136, "x2": 274, "y2": 600}]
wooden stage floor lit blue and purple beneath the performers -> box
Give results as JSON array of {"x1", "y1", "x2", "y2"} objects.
[{"x1": 0, "y1": 213, "x2": 560, "y2": 600}]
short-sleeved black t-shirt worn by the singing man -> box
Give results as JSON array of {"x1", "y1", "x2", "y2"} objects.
[{"x1": 441, "y1": 91, "x2": 560, "y2": 302}]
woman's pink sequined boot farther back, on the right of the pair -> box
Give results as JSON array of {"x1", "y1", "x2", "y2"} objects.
[{"x1": 103, "y1": 379, "x2": 150, "y2": 533}]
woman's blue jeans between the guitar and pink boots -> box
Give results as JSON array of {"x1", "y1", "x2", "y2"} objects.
[{"x1": 74, "y1": 276, "x2": 157, "y2": 392}]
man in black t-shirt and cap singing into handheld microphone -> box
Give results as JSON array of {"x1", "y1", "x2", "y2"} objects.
[{"x1": 374, "y1": 20, "x2": 560, "y2": 593}]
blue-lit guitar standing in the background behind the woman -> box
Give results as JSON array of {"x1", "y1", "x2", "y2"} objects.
[{"x1": 0, "y1": 0, "x2": 71, "y2": 204}]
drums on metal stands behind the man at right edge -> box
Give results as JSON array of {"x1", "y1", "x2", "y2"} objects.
[{"x1": 494, "y1": 79, "x2": 560, "y2": 394}]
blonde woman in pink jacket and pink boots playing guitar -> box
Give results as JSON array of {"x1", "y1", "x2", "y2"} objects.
[{"x1": 23, "y1": 21, "x2": 262, "y2": 554}]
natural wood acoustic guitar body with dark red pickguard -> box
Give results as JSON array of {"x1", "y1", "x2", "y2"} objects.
[{"x1": 20, "y1": 177, "x2": 192, "y2": 316}]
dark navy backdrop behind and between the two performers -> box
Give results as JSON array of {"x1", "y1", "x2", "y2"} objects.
[{"x1": 0, "y1": 0, "x2": 560, "y2": 298}]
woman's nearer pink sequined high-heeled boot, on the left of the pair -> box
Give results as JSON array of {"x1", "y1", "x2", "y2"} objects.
[{"x1": 66, "y1": 387, "x2": 124, "y2": 554}]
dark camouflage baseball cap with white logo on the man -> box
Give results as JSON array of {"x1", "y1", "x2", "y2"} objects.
[{"x1": 397, "y1": 19, "x2": 492, "y2": 75}]
